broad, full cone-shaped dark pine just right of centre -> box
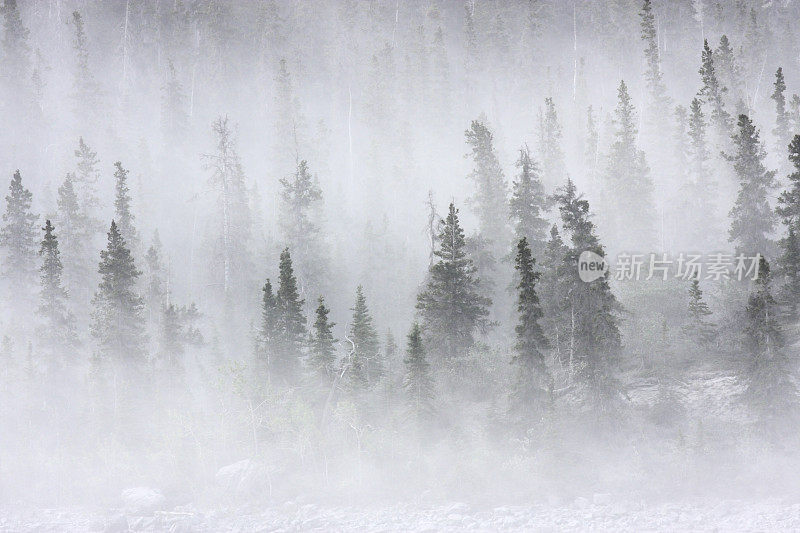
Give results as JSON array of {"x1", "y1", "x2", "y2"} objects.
[{"x1": 417, "y1": 203, "x2": 492, "y2": 362}]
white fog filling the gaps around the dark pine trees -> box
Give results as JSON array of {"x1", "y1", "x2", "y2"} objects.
[{"x1": 0, "y1": 0, "x2": 800, "y2": 531}]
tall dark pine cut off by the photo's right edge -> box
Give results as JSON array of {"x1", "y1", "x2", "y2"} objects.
[{"x1": 775, "y1": 135, "x2": 800, "y2": 321}]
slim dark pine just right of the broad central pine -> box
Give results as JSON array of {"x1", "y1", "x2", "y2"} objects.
[{"x1": 511, "y1": 237, "x2": 551, "y2": 413}]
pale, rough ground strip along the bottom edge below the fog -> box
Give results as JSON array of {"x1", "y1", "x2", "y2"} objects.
[{"x1": 0, "y1": 495, "x2": 800, "y2": 532}]
